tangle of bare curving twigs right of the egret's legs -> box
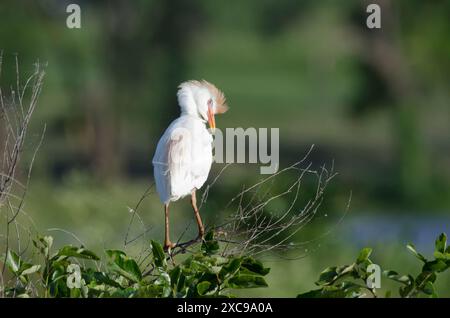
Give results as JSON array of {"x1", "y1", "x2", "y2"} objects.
[{"x1": 163, "y1": 146, "x2": 342, "y2": 257}]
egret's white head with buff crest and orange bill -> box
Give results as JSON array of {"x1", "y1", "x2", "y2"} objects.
[{"x1": 177, "y1": 80, "x2": 228, "y2": 131}]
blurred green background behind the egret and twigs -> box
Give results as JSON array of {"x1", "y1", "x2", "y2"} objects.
[{"x1": 0, "y1": 0, "x2": 450, "y2": 297}]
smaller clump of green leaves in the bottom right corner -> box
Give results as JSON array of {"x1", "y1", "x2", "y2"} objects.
[{"x1": 297, "y1": 233, "x2": 450, "y2": 298}]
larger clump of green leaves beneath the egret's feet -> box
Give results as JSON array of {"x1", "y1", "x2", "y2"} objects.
[{"x1": 1, "y1": 232, "x2": 269, "y2": 298}]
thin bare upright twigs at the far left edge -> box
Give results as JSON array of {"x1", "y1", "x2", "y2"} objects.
[{"x1": 0, "y1": 52, "x2": 46, "y2": 275}]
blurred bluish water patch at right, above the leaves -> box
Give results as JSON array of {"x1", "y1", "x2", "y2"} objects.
[{"x1": 342, "y1": 213, "x2": 450, "y2": 253}]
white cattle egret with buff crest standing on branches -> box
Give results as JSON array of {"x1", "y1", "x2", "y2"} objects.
[{"x1": 152, "y1": 80, "x2": 228, "y2": 250}]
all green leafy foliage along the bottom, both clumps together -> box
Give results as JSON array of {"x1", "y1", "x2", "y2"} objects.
[{"x1": 4, "y1": 232, "x2": 450, "y2": 298}]
